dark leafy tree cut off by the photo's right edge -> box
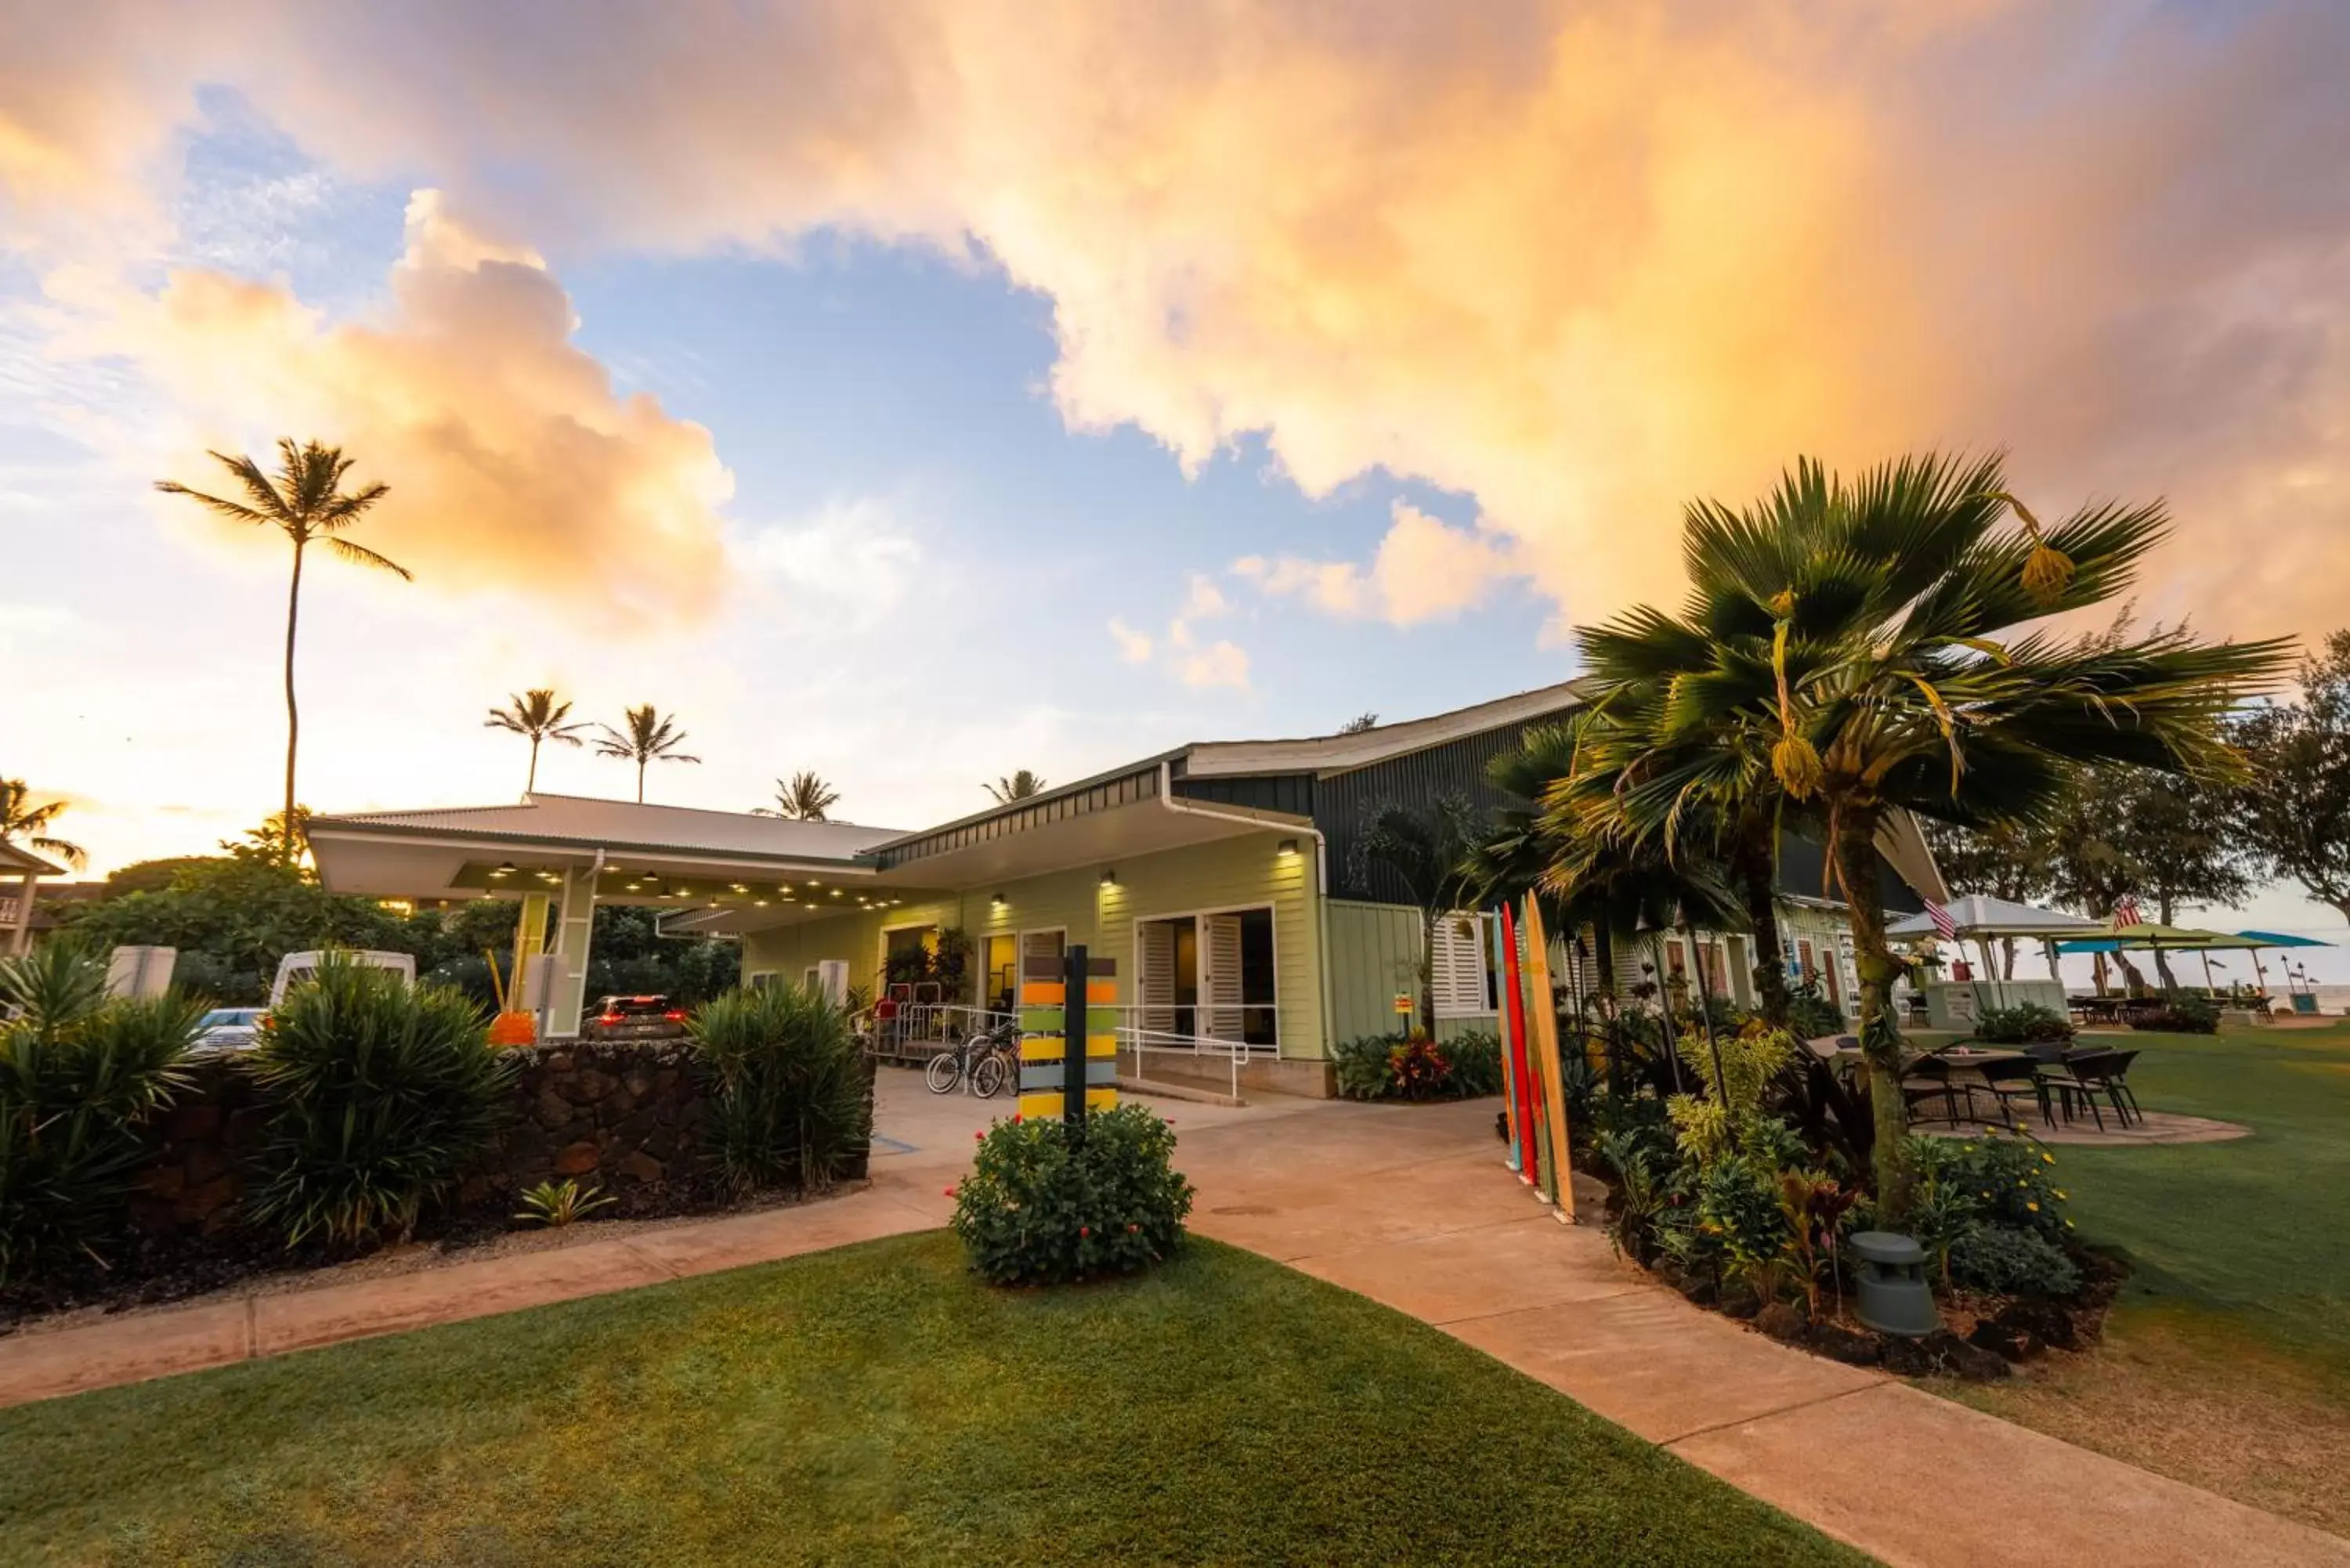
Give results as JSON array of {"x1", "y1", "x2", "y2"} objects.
[{"x1": 2237, "y1": 630, "x2": 2350, "y2": 919}]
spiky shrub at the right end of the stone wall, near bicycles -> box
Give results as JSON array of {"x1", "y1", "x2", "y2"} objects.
[{"x1": 686, "y1": 985, "x2": 872, "y2": 1192}]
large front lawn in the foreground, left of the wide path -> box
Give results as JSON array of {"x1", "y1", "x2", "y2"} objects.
[{"x1": 0, "y1": 1232, "x2": 1861, "y2": 1566}]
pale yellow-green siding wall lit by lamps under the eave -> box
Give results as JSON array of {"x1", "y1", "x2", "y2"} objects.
[{"x1": 743, "y1": 828, "x2": 1335, "y2": 1058}]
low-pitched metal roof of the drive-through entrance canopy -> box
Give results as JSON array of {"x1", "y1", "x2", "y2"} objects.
[{"x1": 310, "y1": 793, "x2": 902, "y2": 861}]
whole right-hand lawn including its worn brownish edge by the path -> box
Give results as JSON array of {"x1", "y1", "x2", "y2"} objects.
[{"x1": 1946, "y1": 1025, "x2": 2350, "y2": 1535}]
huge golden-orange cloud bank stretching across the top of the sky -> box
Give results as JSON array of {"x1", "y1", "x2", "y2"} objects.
[{"x1": 0, "y1": 0, "x2": 2350, "y2": 630}]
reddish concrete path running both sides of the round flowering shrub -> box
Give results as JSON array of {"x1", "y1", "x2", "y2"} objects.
[{"x1": 0, "y1": 1075, "x2": 2350, "y2": 1568}]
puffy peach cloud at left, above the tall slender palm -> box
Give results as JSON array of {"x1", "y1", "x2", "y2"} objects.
[{"x1": 52, "y1": 190, "x2": 733, "y2": 630}]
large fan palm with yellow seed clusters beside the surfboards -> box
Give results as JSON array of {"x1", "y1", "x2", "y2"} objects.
[{"x1": 1579, "y1": 456, "x2": 2289, "y2": 1223}]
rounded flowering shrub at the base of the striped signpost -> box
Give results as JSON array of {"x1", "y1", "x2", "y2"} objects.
[{"x1": 954, "y1": 1105, "x2": 1191, "y2": 1286}]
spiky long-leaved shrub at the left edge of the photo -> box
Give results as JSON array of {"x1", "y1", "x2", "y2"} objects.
[{"x1": 0, "y1": 943, "x2": 204, "y2": 1284}]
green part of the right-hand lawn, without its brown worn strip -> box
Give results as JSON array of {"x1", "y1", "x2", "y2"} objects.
[{"x1": 2056, "y1": 1025, "x2": 2350, "y2": 1373}]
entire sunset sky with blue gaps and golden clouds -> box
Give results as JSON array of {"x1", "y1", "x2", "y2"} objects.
[{"x1": 0, "y1": 0, "x2": 2350, "y2": 976}]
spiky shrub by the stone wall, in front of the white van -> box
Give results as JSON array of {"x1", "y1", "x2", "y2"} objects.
[{"x1": 242, "y1": 955, "x2": 517, "y2": 1246}]
